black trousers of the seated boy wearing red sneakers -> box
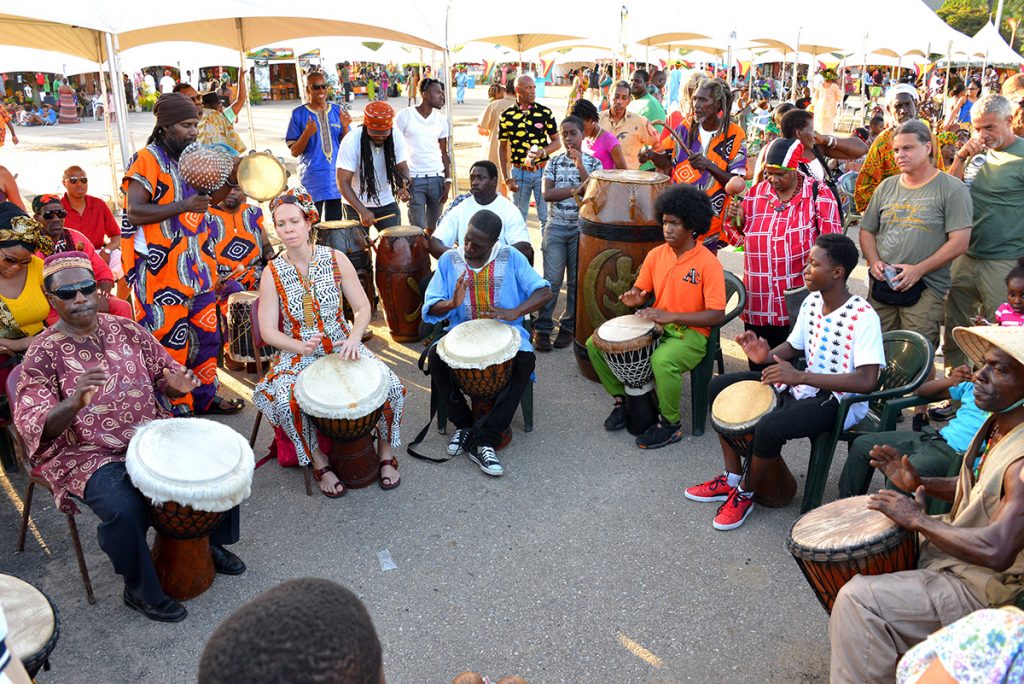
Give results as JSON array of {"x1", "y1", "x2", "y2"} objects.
[{"x1": 708, "y1": 371, "x2": 839, "y2": 459}]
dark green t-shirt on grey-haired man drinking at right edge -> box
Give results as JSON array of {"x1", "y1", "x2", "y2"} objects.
[{"x1": 964, "y1": 138, "x2": 1024, "y2": 259}]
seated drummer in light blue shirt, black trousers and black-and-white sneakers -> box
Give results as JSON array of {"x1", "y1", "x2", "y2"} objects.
[{"x1": 423, "y1": 209, "x2": 552, "y2": 477}]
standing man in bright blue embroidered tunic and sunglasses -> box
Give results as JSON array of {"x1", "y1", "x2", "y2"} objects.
[{"x1": 285, "y1": 72, "x2": 352, "y2": 221}]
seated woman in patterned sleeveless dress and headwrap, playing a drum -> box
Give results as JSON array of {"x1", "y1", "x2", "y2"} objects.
[{"x1": 253, "y1": 188, "x2": 406, "y2": 499}]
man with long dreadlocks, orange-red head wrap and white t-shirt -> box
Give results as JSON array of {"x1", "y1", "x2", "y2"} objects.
[{"x1": 338, "y1": 101, "x2": 409, "y2": 228}]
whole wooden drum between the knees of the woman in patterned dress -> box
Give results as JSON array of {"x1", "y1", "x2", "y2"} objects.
[{"x1": 293, "y1": 354, "x2": 388, "y2": 489}]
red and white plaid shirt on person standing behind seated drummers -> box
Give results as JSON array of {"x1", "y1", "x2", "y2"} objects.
[{"x1": 725, "y1": 172, "x2": 843, "y2": 326}]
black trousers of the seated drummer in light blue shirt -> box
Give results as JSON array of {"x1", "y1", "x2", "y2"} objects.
[{"x1": 430, "y1": 346, "x2": 537, "y2": 448}]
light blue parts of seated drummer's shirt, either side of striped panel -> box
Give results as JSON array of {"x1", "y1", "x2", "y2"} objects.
[{"x1": 423, "y1": 246, "x2": 551, "y2": 351}]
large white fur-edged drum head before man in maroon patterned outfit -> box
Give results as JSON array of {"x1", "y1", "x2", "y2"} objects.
[{"x1": 125, "y1": 418, "x2": 255, "y2": 513}]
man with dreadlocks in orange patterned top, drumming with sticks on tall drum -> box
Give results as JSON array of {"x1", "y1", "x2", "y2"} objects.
[{"x1": 641, "y1": 79, "x2": 746, "y2": 246}]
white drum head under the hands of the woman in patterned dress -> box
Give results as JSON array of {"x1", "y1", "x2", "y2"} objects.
[{"x1": 294, "y1": 354, "x2": 388, "y2": 420}]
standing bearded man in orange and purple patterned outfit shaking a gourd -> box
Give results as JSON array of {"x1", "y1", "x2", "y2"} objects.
[{"x1": 121, "y1": 93, "x2": 244, "y2": 415}]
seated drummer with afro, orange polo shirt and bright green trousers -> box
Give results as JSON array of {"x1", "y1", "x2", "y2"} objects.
[{"x1": 587, "y1": 185, "x2": 725, "y2": 448}]
